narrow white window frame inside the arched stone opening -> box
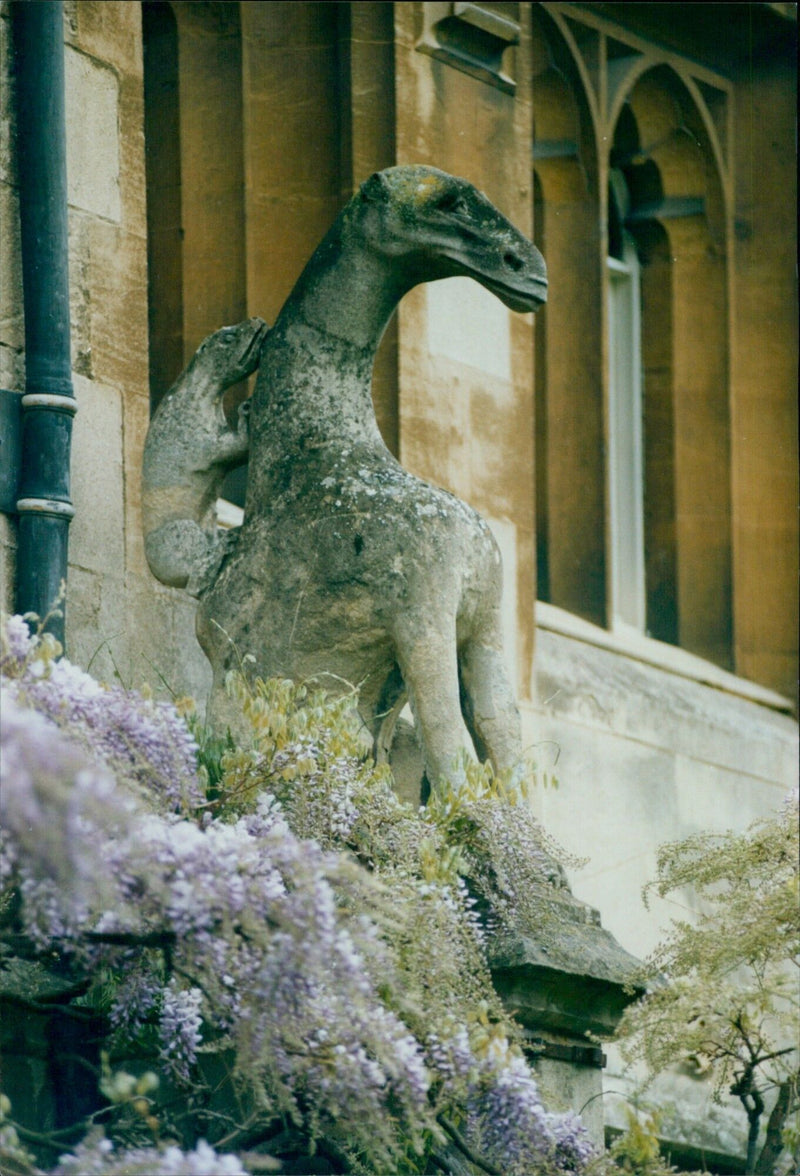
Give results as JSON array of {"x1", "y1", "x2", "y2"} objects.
[{"x1": 607, "y1": 233, "x2": 647, "y2": 633}]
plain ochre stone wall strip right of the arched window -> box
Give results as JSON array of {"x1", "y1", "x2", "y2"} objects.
[{"x1": 732, "y1": 55, "x2": 800, "y2": 697}]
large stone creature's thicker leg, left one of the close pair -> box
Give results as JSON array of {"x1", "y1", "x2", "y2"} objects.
[{"x1": 395, "y1": 615, "x2": 474, "y2": 789}]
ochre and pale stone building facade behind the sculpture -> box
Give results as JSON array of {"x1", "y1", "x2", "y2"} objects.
[{"x1": 0, "y1": 0, "x2": 798, "y2": 1171}]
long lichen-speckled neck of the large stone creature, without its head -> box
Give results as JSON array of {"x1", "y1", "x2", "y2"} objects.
[{"x1": 248, "y1": 222, "x2": 411, "y2": 502}]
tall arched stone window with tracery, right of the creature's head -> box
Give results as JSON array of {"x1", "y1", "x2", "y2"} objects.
[{"x1": 533, "y1": 4, "x2": 733, "y2": 667}]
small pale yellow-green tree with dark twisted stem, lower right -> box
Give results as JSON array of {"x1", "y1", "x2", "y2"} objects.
[{"x1": 619, "y1": 797, "x2": 800, "y2": 1172}]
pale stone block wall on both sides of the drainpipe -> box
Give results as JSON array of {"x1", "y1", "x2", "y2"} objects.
[{"x1": 0, "y1": 0, "x2": 210, "y2": 695}]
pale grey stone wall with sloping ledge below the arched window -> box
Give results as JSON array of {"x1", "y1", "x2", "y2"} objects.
[{"x1": 522, "y1": 604, "x2": 799, "y2": 1157}]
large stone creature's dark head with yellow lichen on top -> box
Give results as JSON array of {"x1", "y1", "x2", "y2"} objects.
[{"x1": 348, "y1": 167, "x2": 547, "y2": 313}]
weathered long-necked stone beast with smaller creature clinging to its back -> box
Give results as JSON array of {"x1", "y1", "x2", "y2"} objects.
[{"x1": 145, "y1": 167, "x2": 547, "y2": 787}]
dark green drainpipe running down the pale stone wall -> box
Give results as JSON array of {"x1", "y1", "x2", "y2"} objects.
[{"x1": 12, "y1": 0, "x2": 78, "y2": 644}]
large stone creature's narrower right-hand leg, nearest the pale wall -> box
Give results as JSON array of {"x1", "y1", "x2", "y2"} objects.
[{"x1": 459, "y1": 610, "x2": 522, "y2": 773}]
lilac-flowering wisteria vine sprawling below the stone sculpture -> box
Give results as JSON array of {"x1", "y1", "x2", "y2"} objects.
[{"x1": 0, "y1": 617, "x2": 593, "y2": 1176}]
